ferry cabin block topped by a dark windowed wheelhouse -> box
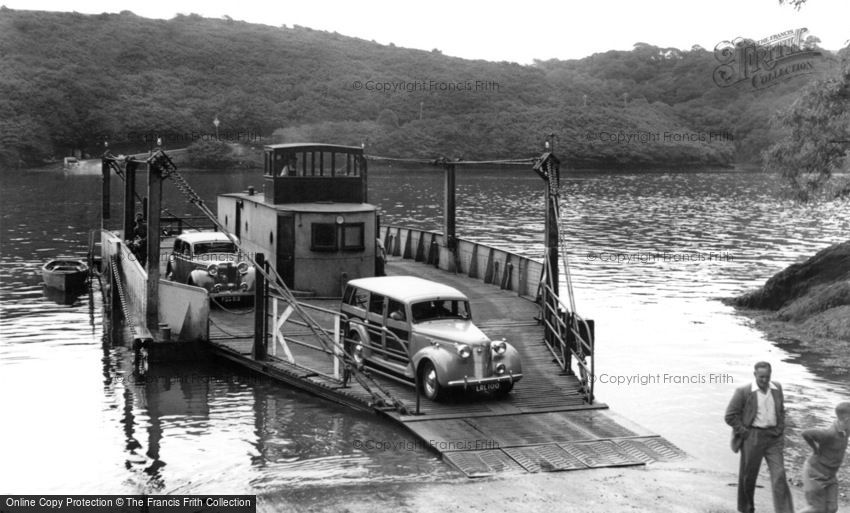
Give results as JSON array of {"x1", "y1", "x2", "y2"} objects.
[{"x1": 218, "y1": 143, "x2": 378, "y2": 297}]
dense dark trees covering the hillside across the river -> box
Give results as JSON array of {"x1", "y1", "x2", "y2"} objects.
[{"x1": 0, "y1": 9, "x2": 838, "y2": 166}]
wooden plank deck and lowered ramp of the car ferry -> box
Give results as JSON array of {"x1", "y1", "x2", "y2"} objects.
[{"x1": 204, "y1": 258, "x2": 685, "y2": 477}]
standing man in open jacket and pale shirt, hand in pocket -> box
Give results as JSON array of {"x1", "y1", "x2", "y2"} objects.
[{"x1": 726, "y1": 362, "x2": 794, "y2": 513}]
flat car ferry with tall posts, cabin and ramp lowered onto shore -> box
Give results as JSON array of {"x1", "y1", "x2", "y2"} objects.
[{"x1": 93, "y1": 143, "x2": 683, "y2": 477}]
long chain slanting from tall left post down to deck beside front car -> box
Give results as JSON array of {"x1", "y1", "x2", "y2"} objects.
[{"x1": 148, "y1": 150, "x2": 406, "y2": 412}]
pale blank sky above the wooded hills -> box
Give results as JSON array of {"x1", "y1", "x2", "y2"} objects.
[{"x1": 0, "y1": 0, "x2": 850, "y2": 64}]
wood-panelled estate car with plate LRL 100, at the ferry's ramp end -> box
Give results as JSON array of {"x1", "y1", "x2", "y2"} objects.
[{"x1": 341, "y1": 276, "x2": 522, "y2": 400}]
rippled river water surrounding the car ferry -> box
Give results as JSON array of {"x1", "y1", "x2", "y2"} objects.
[{"x1": 0, "y1": 167, "x2": 850, "y2": 494}]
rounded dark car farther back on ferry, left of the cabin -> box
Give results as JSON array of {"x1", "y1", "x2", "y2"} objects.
[{"x1": 165, "y1": 231, "x2": 255, "y2": 299}]
